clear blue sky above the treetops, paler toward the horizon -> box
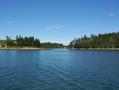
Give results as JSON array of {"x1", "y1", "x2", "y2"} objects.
[{"x1": 0, "y1": 0, "x2": 119, "y2": 44}]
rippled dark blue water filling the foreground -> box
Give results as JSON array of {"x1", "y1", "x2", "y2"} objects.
[{"x1": 0, "y1": 49, "x2": 119, "y2": 90}]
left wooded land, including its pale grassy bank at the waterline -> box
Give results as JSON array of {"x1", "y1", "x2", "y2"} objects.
[{"x1": 0, "y1": 35, "x2": 63, "y2": 49}]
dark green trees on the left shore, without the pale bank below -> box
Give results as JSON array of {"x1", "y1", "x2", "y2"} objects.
[{"x1": 0, "y1": 35, "x2": 63, "y2": 48}]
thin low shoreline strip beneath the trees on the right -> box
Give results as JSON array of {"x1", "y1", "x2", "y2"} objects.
[{"x1": 71, "y1": 48, "x2": 119, "y2": 51}]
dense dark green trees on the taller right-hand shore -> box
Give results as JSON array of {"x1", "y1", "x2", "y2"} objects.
[{"x1": 69, "y1": 32, "x2": 119, "y2": 49}]
